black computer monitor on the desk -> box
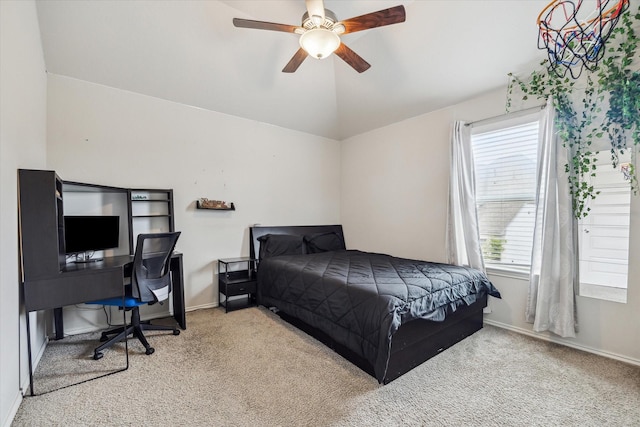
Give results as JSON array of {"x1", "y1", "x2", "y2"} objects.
[{"x1": 64, "y1": 216, "x2": 120, "y2": 262}]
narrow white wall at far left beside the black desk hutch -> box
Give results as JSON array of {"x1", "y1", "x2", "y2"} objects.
[{"x1": 0, "y1": 0, "x2": 47, "y2": 426}]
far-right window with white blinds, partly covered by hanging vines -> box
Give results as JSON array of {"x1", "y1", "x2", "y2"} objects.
[{"x1": 578, "y1": 151, "x2": 631, "y2": 302}]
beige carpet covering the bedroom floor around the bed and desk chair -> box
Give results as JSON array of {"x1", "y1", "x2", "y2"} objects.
[{"x1": 13, "y1": 308, "x2": 640, "y2": 427}]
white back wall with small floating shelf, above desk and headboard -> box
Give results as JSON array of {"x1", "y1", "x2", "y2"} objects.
[{"x1": 47, "y1": 75, "x2": 340, "y2": 316}]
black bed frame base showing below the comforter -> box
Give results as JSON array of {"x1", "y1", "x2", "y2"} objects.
[{"x1": 276, "y1": 296, "x2": 487, "y2": 384}]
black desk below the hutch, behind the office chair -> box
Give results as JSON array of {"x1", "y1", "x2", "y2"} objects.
[{"x1": 23, "y1": 253, "x2": 187, "y2": 394}]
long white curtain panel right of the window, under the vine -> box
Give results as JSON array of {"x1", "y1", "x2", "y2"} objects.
[{"x1": 526, "y1": 100, "x2": 577, "y2": 337}]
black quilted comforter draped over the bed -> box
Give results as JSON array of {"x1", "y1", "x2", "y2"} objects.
[{"x1": 258, "y1": 250, "x2": 500, "y2": 381}]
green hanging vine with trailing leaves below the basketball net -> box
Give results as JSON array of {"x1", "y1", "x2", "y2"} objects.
[{"x1": 507, "y1": 1, "x2": 640, "y2": 219}]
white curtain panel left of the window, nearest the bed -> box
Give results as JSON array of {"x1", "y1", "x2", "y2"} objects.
[{"x1": 447, "y1": 121, "x2": 485, "y2": 271}]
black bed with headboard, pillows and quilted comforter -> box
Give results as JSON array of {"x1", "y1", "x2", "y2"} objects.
[{"x1": 250, "y1": 225, "x2": 500, "y2": 384}]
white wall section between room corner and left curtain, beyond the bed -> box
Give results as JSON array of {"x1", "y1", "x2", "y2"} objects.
[{"x1": 341, "y1": 111, "x2": 449, "y2": 261}]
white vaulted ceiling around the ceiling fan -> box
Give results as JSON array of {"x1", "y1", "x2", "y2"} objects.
[{"x1": 37, "y1": 0, "x2": 548, "y2": 140}]
